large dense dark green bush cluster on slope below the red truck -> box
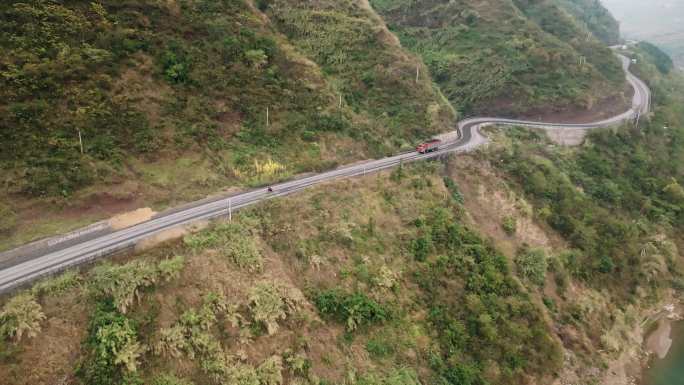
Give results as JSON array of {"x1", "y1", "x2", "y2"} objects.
[{"x1": 408, "y1": 209, "x2": 562, "y2": 385}]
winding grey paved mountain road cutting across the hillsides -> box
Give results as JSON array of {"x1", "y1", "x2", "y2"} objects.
[{"x1": 0, "y1": 56, "x2": 651, "y2": 293}]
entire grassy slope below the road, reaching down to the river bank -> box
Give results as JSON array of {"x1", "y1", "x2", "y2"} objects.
[{"x1": 0, "y1": 45, "x2": 684, "y2": 385}]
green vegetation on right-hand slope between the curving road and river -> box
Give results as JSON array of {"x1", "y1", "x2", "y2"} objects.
[{"x1": 472, "y1": 48, "x2": 684, "y2": 370}]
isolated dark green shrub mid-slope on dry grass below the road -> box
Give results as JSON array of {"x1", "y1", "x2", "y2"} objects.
[{"x1": 314, "y1": 289, "x2": 389, "y2": 331}]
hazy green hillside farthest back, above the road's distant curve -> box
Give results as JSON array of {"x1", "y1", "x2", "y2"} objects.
[{"x1": 371, "y1": 0, "x2": 624, "y2": 116}]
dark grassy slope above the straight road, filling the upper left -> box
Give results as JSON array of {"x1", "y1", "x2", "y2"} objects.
[{"x1": 0, "y1": 0, "x2": 454, "y2": 247}]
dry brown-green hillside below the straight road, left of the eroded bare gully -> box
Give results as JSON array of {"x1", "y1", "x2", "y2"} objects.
[{"x1": 0, "y1": 163, "x2": 562, "y2": 385}]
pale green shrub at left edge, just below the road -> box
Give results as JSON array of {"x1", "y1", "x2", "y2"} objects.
[{"x1": 0, "y1": 293, "x2": 45, "y2": 342}]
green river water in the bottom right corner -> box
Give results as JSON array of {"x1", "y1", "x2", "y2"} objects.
[{"x1": 643, "y1": 322, "x2": 684, "y2": 385}]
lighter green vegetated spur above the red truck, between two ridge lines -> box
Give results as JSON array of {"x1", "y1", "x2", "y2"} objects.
[{"x1": 267, "y1": 0, "x2": 454, "y2": 146}]
